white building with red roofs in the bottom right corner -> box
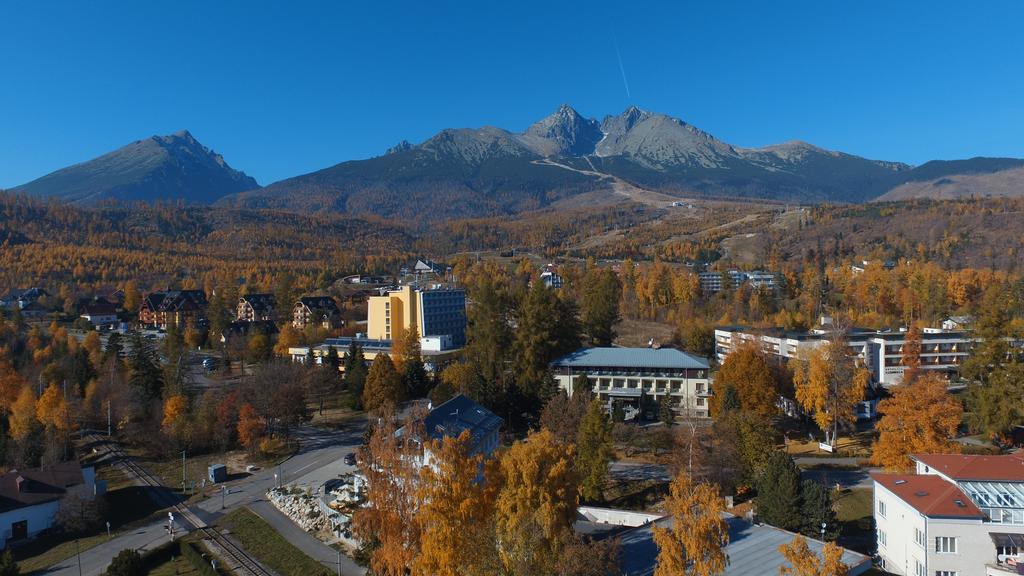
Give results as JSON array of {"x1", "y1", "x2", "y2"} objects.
[{"x1": 871, "y1": 452, "x2": 1024, "y2": 576}]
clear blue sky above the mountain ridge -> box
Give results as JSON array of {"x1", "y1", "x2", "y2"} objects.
[{"x1": 0, "y1": 0, "x2": 1024, "y2": 188}]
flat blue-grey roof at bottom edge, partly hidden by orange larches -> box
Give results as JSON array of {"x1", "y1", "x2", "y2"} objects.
[{"x1": 618, "y1": 515, "x2": 871, "y2": 576}]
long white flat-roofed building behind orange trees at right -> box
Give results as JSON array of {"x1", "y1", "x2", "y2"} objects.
[{"x1": 715, "y1": 326, "x2": 975, "y2": 386}]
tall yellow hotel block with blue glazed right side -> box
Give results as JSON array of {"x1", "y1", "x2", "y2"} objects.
[{"x1": 367, "y1": 285, "x2": 466, "y2": 348}]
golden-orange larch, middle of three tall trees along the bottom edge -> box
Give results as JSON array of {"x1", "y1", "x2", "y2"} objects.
[{"x1": 412, "y1": 430, "x2": 496, "y2": 576}]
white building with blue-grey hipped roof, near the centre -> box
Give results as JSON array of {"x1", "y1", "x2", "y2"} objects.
[{"x1": 551, "y1": 347, "x2": 711, "y2": 417}]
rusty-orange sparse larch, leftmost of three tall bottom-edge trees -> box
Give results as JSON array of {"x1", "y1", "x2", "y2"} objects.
[{"x1": 352, "y1": 407, "x2": 423, "y2": 576}]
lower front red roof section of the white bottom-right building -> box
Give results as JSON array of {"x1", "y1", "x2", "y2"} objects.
[{"x1": 871, "y1": 474, "x2": 984, "y2": 518}]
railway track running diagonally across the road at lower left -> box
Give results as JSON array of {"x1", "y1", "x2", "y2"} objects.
[{"x1": 83, "y1": 433, "x2": 276, "y2": 576}]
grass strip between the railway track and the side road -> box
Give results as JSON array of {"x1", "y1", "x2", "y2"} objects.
[{"x1": 219, "y1": 508, "x2": 328, "y2": 576}]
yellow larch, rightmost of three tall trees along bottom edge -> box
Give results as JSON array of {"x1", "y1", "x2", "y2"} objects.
[{"x1": 495, "y1": 430, "x2": 579, "y2": 576}]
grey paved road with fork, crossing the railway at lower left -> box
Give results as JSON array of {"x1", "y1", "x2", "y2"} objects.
[{"x1": 43, "y1": 416, "x2": 366, "y2": 576}]
